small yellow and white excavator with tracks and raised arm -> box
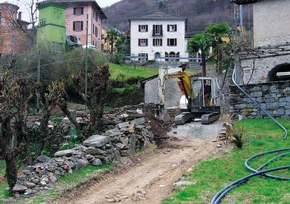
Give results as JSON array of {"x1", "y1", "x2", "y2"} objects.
[{"x1": 158, "y1": 65, "x2": 220, "y2": 125}]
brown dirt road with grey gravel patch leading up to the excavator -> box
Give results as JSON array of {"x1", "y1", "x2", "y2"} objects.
[{"x1": 58, "y1": 121, "x2": 222, "y2": 204}]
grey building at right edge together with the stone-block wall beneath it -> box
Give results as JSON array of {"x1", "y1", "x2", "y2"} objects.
[{"x1": 230, "y1": 0, "x2": 290, "y2": 118}]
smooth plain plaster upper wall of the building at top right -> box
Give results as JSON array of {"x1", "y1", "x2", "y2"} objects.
[{"x1": 253, "y1": 0, "x2": 290, "y2": 47}]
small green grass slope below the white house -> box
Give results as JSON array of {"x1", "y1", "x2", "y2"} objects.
[{"x1": 110, "y1": 64, "x2": 158, "y2": 81}]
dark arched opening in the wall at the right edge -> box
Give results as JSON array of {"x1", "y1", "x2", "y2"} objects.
[{"x1": 267, "y1": 63, "x2": 290, "y2": 82}]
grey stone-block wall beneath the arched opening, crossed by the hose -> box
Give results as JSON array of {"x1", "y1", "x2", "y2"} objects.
[{"x1": 230, "y1": 81, "x2": 290, "y2": 118}]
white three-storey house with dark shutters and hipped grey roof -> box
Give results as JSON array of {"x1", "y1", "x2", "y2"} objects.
[{"x1": 129, "y1": 12, "x2": 188, "y2": 62}]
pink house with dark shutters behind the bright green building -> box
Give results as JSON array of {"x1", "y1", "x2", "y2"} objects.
[{"x1": 41, "y1": 0, "x2": 107, "y2": 50}]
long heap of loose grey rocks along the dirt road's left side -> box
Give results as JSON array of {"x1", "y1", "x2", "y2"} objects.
[{"x1": 13, "y1": 107, "x2": 154, "y2": 198}]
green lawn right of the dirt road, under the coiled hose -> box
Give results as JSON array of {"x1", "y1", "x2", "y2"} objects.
[{"x1": 162, "y1": 119, "x2": 290, "y2": 204}]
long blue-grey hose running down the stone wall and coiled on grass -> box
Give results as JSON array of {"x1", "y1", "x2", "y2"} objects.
[{"x1": 211, "y1": 67, "x2": 290, "y2": 204}]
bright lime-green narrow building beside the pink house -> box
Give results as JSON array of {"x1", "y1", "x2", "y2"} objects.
[{"x1": 37, "y1": 2, "x2": 66, "y2": 50}]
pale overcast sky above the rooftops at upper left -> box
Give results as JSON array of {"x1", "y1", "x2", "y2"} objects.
[{"x1": 0, "y1": 0, "x2": 121, "y2": 21}]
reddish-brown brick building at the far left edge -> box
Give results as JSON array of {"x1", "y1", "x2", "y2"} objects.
[{"x1": 0, "y1": 2, "x2": 29, "y2": 55}]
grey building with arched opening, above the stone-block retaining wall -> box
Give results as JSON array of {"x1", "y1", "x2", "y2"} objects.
[{"x1": 235, "y1": 0, "x2": 290, "y2": 84}]
